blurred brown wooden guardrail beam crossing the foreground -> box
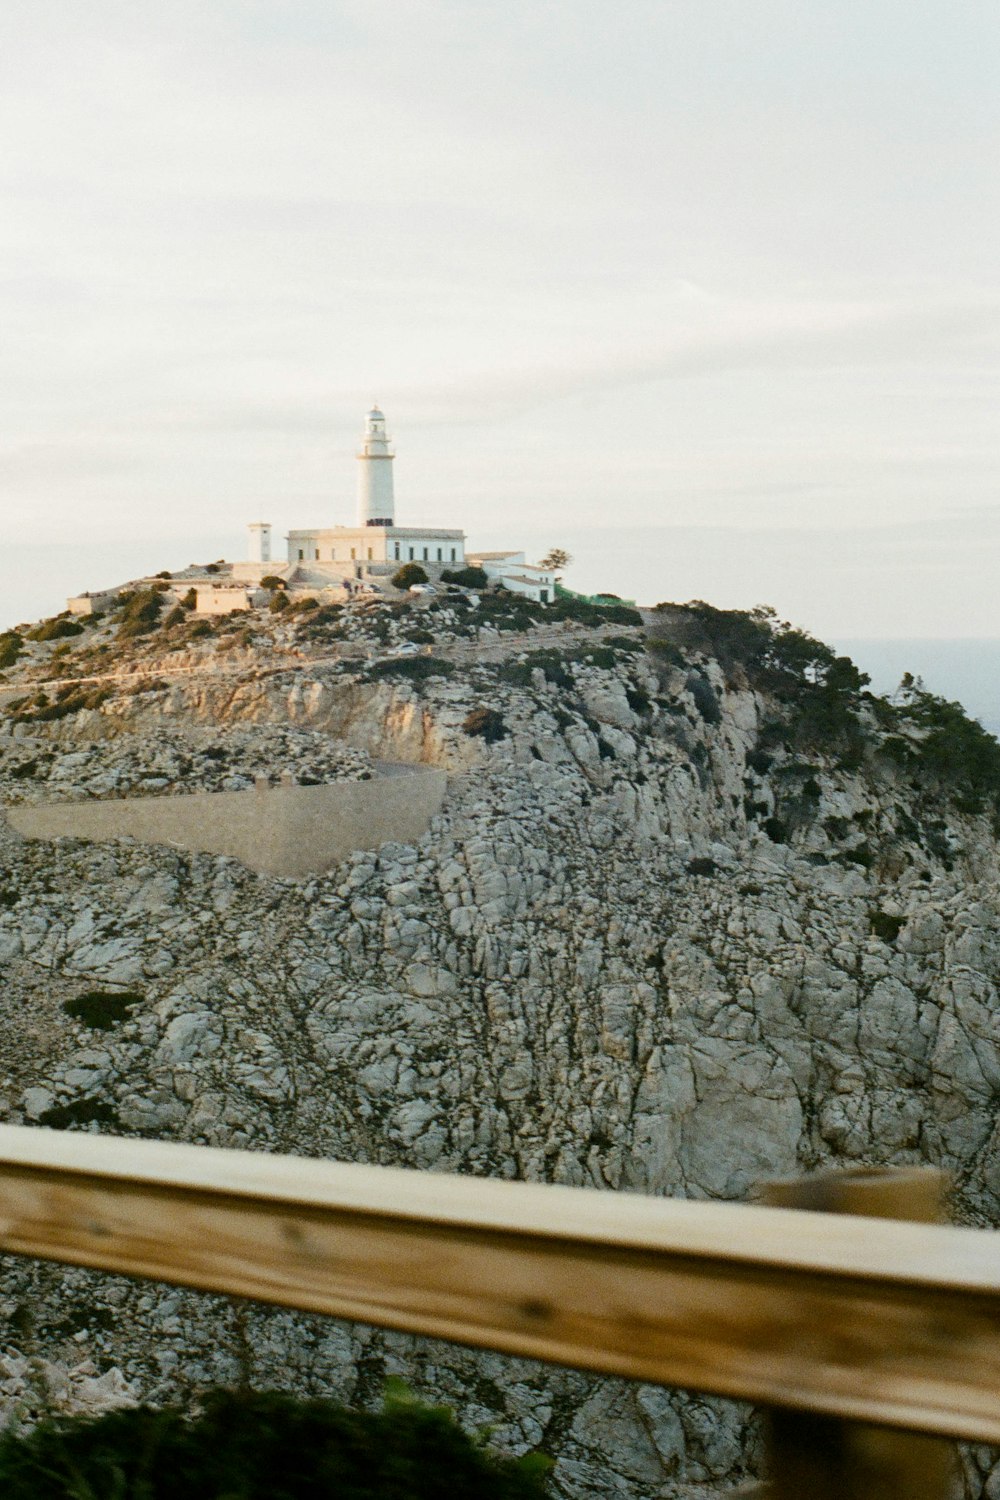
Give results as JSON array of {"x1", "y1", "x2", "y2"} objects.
[{"x1": 0, "y1": 1127, "x2": 1000, "y2": 1443}]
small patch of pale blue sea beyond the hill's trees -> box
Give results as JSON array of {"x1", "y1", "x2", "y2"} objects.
[{"x1": 831, "y1": 638, "x2": 1000, "y2": 738}]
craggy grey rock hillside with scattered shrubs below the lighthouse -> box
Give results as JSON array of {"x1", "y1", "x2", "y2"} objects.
[{"x1": 0, "y1": 590, "x2": 1000, "y2": 1497}]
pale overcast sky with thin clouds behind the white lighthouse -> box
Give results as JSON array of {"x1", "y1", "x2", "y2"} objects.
[{"x1": 0, "y1": 0, "x2": 1000, "y2": 636}]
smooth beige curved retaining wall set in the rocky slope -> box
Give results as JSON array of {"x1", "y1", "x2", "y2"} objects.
[{"x1": 7, "y1": 765, "x2": 447, "y2": 875}]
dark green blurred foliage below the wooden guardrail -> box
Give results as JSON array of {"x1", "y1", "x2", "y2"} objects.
[{"x1": 0, "y1": 1392, "x2": 550, "y2": 1500}]
